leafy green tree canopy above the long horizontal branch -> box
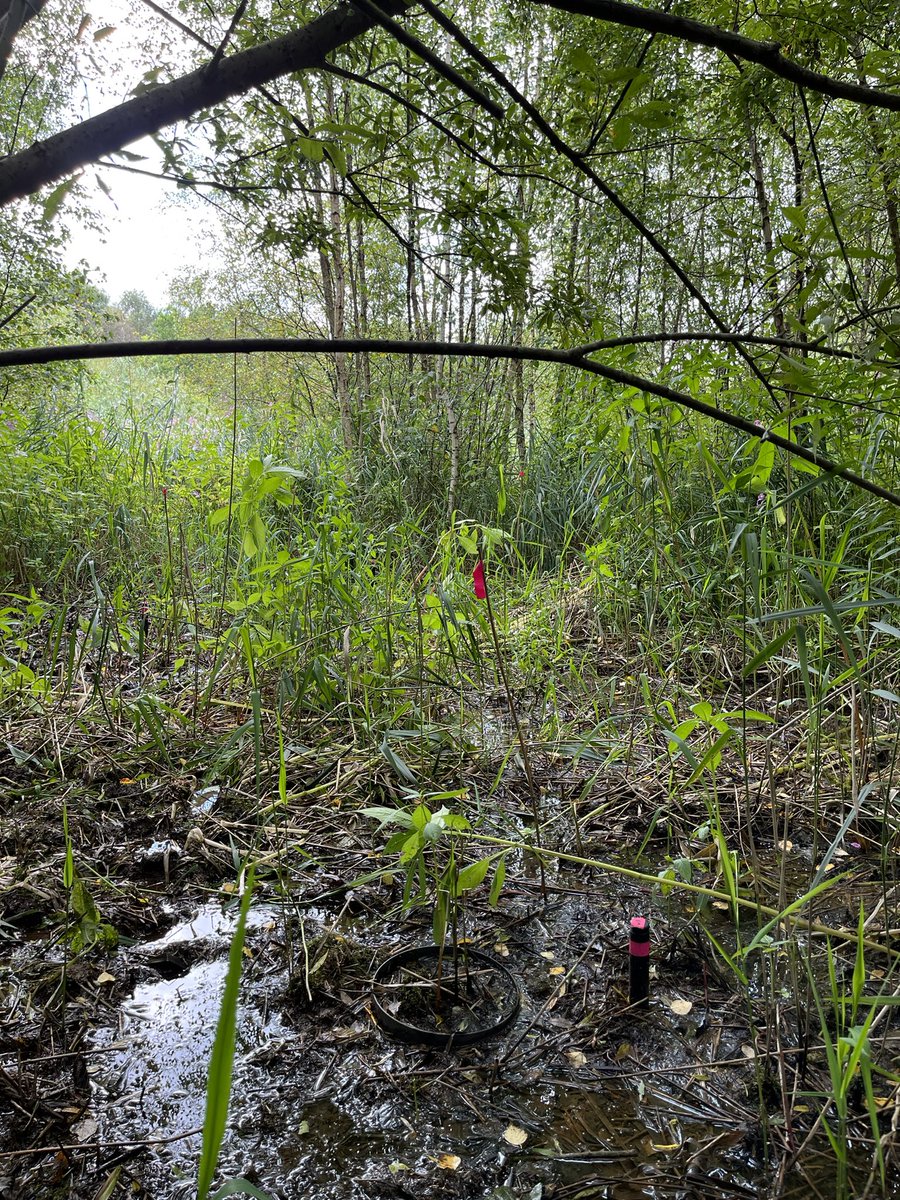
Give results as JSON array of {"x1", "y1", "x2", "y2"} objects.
[{"x1": 0, "y1": 0, "x2": 900, "y2": 508}]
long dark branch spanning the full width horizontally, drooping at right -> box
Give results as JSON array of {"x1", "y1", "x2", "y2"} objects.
[{"x1": 0, "y1": 337, "x2": 900, "y2": 509}]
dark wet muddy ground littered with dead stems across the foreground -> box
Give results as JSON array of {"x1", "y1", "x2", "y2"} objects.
[{"x1": 0, "y1": 700, "x2": 900, "y2": 1200}]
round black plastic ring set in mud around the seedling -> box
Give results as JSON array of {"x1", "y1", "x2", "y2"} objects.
[{"x1": 372, "y1": 946, "x2": 522, "y2": 1049}]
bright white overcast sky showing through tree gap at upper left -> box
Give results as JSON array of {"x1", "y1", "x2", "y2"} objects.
[{"x1": 60, "y1": 0, "x2": 216, "y2": 306}]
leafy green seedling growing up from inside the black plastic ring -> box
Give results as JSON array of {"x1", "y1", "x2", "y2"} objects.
[{"x1": 362, "y1": 788, "x2": 506, "y2": 1013}]
